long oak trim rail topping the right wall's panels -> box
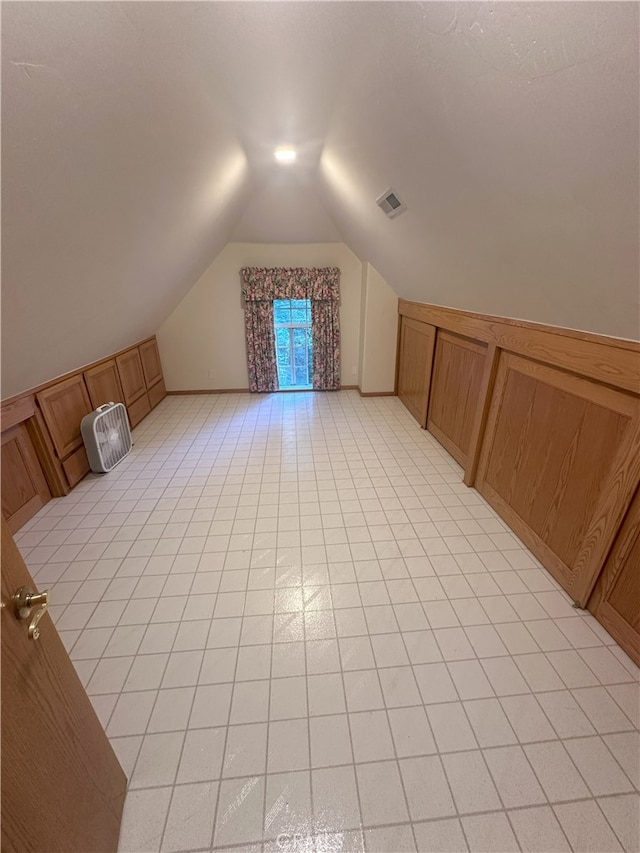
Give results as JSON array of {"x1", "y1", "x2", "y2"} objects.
[{"x1": 398, "y1": 299, "x2": 640, "y2": 394}]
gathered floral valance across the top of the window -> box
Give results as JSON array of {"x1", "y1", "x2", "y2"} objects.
[{"x1": 240, "y1": 267, "x2": 340, "y2": 302}]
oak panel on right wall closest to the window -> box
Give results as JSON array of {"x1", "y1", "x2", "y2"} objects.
[{"x1": 398, "y1": 317, "x2": 436, "y2": 428}]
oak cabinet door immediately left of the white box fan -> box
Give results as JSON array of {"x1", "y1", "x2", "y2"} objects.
[{"x1": 37, "y1": 373, "x2": 91, "y2": 459}]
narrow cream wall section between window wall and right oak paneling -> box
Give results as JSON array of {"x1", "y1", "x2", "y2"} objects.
[{"x1": 360, "y1": 264, "x2": 398, "y2": 394}]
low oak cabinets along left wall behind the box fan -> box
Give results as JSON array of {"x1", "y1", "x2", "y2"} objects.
[{"x1": 2, "y1": 338, "x2": 166, "y2": 531}]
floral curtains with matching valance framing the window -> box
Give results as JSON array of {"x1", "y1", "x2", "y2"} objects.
[{"x1": 240, "y1": 267, "x2": 340, "y2": 391}]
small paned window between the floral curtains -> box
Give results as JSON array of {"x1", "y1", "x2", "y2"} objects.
[{"x1": 273, "y1": 299, "x2": 313, "y2": 389}]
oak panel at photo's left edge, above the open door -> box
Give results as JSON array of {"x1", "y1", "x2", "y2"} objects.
[{"x1": 2, "y1": 423, "x2": 51, "y2": 531}]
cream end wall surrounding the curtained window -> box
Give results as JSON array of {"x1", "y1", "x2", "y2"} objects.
[{"x1": 157, "y1": 243, "x2": 364, "y2": 391}]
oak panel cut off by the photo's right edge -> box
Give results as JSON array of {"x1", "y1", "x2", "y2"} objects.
[{"x1": 588, "y1": 490, "x2": 640, "y2": 666}]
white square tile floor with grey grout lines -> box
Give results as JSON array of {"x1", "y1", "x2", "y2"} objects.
[{"x1": 17, "y1": 392, "x2": 640, "y2": 853}]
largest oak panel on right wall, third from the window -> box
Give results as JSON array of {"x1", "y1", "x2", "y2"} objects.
[{"x1": 477, "y1": 353, "x2": 639, "y2": 604}]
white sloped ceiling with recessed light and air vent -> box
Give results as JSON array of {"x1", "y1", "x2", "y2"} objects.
[{"x1": 2, "y1": 2, "x2": 640, "y2": 397}]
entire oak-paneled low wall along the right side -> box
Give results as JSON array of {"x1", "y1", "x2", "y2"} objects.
[{"x1": 397, "y1": 300, "x2": 640, "y2": 648}]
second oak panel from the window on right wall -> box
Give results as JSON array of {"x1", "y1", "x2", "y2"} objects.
[{"x1": 427, "y1": 329, "x2": 487, "y2": 466}]
